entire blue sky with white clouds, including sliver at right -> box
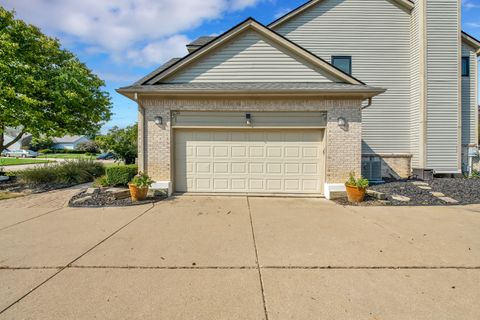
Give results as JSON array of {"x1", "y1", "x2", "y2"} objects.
[{"x1": 0, "y1": 0, "x2": 480, "y2": 131}]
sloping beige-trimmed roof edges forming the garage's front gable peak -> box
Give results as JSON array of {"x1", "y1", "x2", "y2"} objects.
[{"x1": 136, "y1": 18, "x2": 364, "y2": 85}]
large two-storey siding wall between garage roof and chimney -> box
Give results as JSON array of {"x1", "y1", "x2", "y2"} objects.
[{"x1": 275, "y1": 0, "x2": 410, "y2": 153}]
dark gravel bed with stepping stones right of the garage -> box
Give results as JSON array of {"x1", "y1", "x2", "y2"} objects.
[{"x1": 335, "y1": 178, "x2": 480, "y2": 206}]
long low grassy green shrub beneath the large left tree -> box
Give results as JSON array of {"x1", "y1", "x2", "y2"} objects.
[{"x1": 15, "y1": 159, "x2": 105, "y2": 185}]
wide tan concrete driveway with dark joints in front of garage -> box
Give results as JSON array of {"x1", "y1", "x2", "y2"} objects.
[{"x1": 0, "y1": 191, "x2": 480, "y2": 320}]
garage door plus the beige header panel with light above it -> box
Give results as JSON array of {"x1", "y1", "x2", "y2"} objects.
[{"x1": 172, "y1": 112, "x2": 326, "y2": 194}]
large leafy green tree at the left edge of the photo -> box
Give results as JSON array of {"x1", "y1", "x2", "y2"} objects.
[{"x1": 0, "y1": 7, "x2": 111, "y2": 150}]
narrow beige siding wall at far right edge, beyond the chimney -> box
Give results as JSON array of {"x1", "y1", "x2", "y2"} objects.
[{"x1": 462, "y1": 44, "x2": 478, "y2": 144}]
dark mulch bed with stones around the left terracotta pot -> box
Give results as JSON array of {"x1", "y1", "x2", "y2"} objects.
[{"x1": 68, "y1": 188, "x2": 167, "y2": 208}]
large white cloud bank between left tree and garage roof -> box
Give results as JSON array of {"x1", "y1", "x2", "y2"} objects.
[{"x1": 0, "y1": 0, "x2": 262, "y2": 65}]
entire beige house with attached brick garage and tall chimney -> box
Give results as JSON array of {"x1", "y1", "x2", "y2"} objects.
[{"x1": 118, "y1": 0, "x2": 480, "y2": 198}]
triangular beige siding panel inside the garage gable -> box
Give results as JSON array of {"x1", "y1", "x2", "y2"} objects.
[{"x1": 163, "y1": 30, "x2": 333, "y2": 83}]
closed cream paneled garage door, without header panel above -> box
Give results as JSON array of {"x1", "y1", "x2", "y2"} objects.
[{"x1": 175, "y1": 129, "x2": 324, "y2": 194}]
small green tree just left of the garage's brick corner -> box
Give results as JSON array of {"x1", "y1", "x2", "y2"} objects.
[{"x1": 95, "y1": 124, "x2": 138, "y2": 164}]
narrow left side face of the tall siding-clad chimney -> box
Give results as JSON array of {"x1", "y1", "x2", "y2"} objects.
[{"x1": 410, "y1": 6, "x2": 423, "y2": 168}]
